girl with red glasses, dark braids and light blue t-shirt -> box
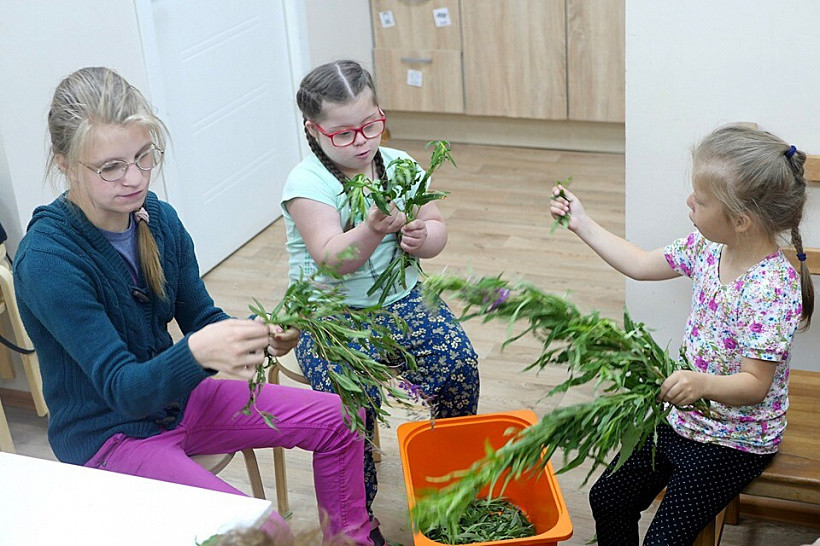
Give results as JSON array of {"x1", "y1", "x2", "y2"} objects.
[{"x1": 282, "y1": 60, "x2": 479, "y2": 545}]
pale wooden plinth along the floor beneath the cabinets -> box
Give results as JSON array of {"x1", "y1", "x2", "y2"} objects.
[{"x1": 387, "y1": 111, "x2": 626, "y2": 154}]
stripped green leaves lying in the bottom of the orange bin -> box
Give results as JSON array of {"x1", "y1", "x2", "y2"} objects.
[{"x1": 424, "y1": 498, "x2": 535, "y2": 544}]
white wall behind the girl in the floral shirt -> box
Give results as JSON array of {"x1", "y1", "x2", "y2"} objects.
[{"x1": 626, "y1": 0, "x2": 820, "y2": 370}]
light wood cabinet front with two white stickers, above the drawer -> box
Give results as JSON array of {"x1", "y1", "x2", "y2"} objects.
[{"x1": 370, "y1": 0, "x2": 461, "y2": 50}]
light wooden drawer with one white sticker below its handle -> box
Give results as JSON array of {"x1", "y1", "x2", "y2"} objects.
[{"x1": 373, "y1": 49, "x2": 464, "y2": 114}]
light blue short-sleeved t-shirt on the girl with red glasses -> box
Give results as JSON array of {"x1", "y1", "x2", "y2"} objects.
[{"x1": 282, "y1": 147, "x2": 419, "y2": 307}]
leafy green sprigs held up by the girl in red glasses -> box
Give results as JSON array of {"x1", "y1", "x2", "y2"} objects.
[{"x1": 345, "y1": 140, "x2": 455, "y2": 305}]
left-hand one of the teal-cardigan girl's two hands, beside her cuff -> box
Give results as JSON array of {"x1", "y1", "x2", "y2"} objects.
[{"x1": 188, "y1": 319, "x2": 269, "y2": 379}]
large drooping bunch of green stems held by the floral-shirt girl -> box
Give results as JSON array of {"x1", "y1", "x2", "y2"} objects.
[{"x1": 413, "y1": 275, "x2": 710, "y2": 530}]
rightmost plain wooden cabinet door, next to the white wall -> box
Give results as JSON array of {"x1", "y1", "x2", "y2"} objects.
[{"x1": 567, "y1": 0, "x2": 626, "y2": 122}]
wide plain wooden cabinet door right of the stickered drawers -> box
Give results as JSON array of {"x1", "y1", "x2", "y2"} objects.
[{"x1": 461, "y1": 0, "x2": 567, "y2": 119}]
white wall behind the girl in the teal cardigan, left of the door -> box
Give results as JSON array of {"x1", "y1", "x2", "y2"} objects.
[{"x1": 0, "y1": 0, "x2": 148, "y2": 390}]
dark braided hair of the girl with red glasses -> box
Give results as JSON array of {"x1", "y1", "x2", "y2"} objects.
[{"x1": 296, "y1": 60, "x2": 387, "y2": 185}]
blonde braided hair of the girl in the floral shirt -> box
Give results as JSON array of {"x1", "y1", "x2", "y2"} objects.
[{"x1": 692, "y1": 124, "x2": 814, "y2": 330}]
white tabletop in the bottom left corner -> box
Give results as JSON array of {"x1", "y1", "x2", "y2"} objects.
[{"x1": 0, "y1": 453, "x2": 273, "y2": 546}]
